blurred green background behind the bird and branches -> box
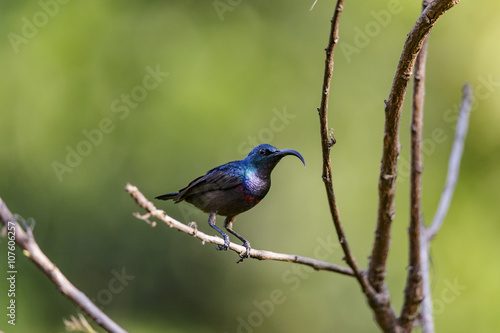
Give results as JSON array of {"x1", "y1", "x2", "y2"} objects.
[{"x1": 0, "y1": 0, "x2": 500, "y2": 332}]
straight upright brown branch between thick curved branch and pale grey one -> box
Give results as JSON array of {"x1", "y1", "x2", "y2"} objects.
[{"x1": 399, "y1": 0, "x2": 429, "y2": 326}]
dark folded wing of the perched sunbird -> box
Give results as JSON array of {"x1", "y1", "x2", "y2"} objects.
[{"x1": 174, "y1": 163, "x2": 244, "y2": 202}]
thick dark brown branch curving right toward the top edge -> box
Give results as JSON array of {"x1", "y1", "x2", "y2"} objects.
[{"x1": 368, "y1": 0, "x2": 459, "y2": 292}]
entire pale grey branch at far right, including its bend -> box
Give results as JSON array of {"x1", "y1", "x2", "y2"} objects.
[{"x1": 420, "y1": 84, "x2": 473, "y2": 333}]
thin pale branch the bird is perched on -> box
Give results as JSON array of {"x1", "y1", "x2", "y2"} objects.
[{"x1": 125, "y1": 184, "x2": 353, "y2": 276}]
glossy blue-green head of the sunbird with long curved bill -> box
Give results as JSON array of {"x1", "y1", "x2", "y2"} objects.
[{"x1": 244, "y1": 144, "x2": 306, "y2": 175}]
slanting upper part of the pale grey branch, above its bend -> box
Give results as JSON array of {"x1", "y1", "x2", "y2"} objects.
[{"x1": 427, "y1": 84, "x2": 472, "y2": 240}]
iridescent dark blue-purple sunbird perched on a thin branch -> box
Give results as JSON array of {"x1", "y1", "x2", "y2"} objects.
[{"x1": 156, "y1": 144, "x2": 306, "y2": 258}]
